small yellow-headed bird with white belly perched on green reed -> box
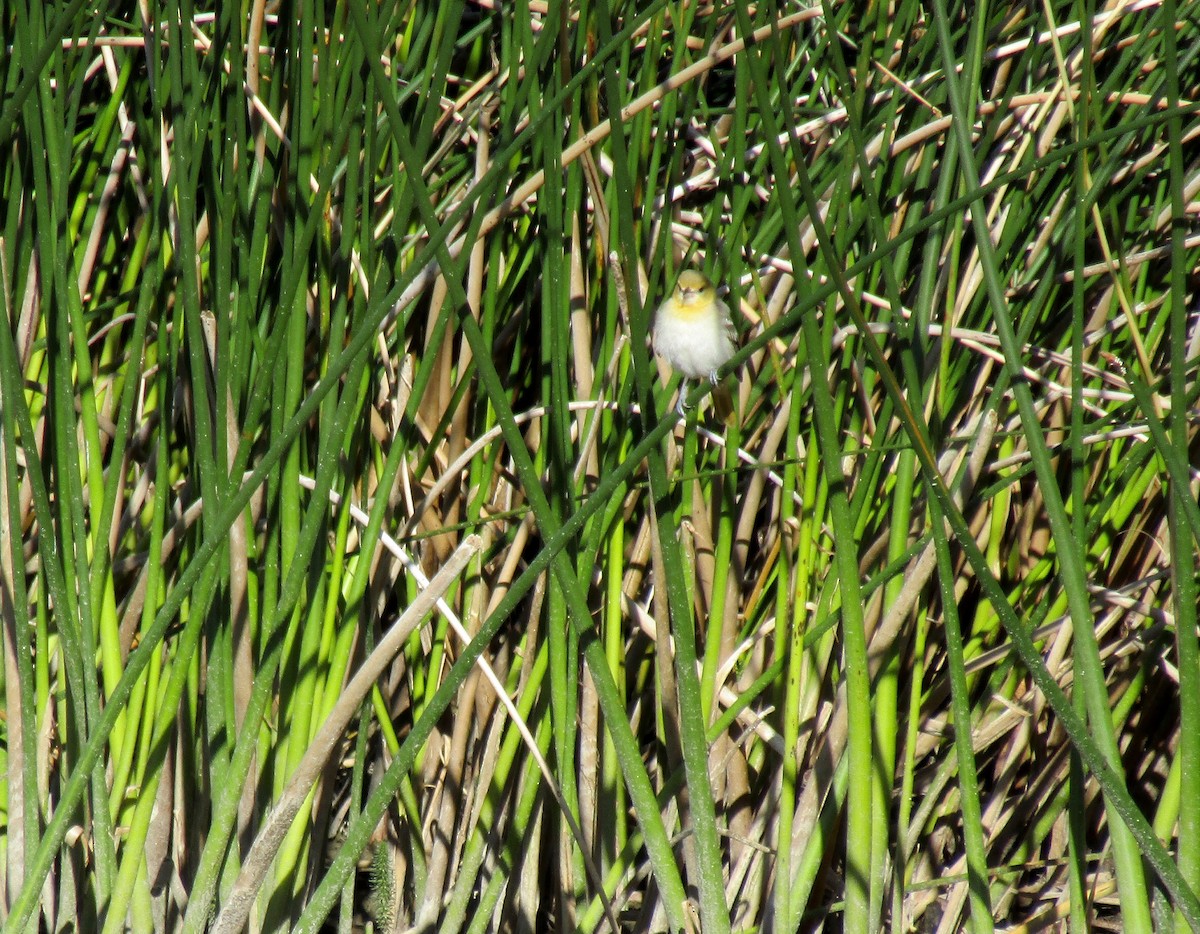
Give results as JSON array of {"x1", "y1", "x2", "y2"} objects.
[{"x1": 652, "y1": 269, "x2": 737, "y2": 418}]
